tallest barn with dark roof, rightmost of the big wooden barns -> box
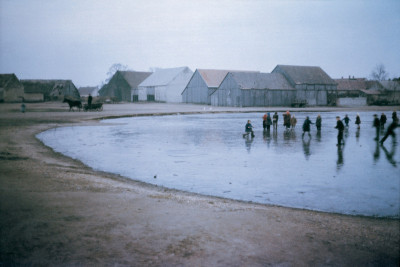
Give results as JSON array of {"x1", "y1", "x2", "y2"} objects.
[{"x1": 272, "y1": 65, "x2": 337, "y2": 106}]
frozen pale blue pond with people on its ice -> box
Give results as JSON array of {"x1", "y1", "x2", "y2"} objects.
[{"x1": 38, "y1": 112, "x2": 400, "y2": 218}]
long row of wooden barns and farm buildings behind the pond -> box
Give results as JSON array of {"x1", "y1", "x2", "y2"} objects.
[{"x1": 0, "y1": 65, "x2": 400, "y2": 107}]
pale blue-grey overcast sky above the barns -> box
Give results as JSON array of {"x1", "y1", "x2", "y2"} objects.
[{"x1": 0, "y1": 0, "x2": 400, "y2": 87}]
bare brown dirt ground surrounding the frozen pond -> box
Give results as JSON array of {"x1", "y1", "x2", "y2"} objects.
[{"x1": 0, "y1": 102, "x2": 400, "y2": 266}]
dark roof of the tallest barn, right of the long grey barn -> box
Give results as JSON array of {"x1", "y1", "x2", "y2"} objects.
[{"x1": 272, "y1": 65, "x2": 336, "y2": 85}]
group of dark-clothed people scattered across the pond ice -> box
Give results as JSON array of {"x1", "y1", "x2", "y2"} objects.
[{"x1": 243, "y1": 111, "x2": 399, "y2": 147}]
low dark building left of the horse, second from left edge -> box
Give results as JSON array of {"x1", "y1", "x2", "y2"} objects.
[{"x1": 21, "y1": 80, "x2": 80, "y2": 102}]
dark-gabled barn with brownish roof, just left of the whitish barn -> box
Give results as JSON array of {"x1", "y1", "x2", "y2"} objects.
[{"x1": 99, "y1": 71, "x2": 151, "y2": 102}]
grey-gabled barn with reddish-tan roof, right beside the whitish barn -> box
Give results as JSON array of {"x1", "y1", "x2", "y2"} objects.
[{"x1": 182, "y1": 69, "x2": 233, "y2": 105}]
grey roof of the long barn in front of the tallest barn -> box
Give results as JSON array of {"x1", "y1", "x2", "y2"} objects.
[{"x1": 231, "y1": 72, "x2": 294, "y2": 90}]
